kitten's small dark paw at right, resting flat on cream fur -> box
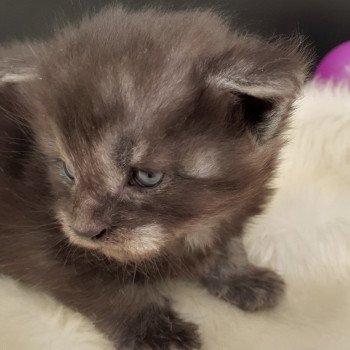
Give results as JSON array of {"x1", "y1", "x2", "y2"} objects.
[{"x1": 218, "y1": 268, "x2": 285, "y2": 311}]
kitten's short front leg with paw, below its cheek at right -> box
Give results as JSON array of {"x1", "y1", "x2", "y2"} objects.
[{"x1": 201, "y1": 238, "x2": 285, "y2": 311}]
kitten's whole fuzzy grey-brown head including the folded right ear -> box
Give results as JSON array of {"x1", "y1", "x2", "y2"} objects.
[{"x1": 2, "y1": 9, "x2": 306, "y2": 261}]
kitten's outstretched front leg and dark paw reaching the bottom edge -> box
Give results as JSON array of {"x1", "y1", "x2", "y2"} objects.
[{"x1": 45, "y1": 274, "x2": 200, "y2": 350}]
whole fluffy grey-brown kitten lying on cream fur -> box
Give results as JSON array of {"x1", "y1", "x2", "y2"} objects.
[{"x1": 0, "y1": 8, "x2": 307, "y2": 349}]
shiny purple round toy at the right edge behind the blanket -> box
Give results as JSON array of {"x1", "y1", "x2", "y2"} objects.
[{"x1": 315, "y1": 41, "x2": 350, "y2": 85}]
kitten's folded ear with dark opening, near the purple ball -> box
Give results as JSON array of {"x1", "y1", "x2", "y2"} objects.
[{"x1": 207, "y1": 38, "x2": 310, "y2": 142}]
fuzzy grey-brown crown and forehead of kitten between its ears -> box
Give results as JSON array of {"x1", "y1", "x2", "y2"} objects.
[{"x1": 40, "y1": 8, "x2": 226, "y2": 138}]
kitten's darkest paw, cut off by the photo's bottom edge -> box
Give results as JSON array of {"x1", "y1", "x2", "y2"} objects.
[{"x1": 122, "y1": 307, "x2": 201, "y2": 350}]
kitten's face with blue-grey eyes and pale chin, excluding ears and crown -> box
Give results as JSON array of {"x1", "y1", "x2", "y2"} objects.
[{"x1": 32, "y1": 65, "x2": 263, "y2": 261}]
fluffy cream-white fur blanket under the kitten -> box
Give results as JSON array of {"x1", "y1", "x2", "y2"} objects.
[{"x1": 0, "y1": 84, "x2": 350, "y2": 350}]
